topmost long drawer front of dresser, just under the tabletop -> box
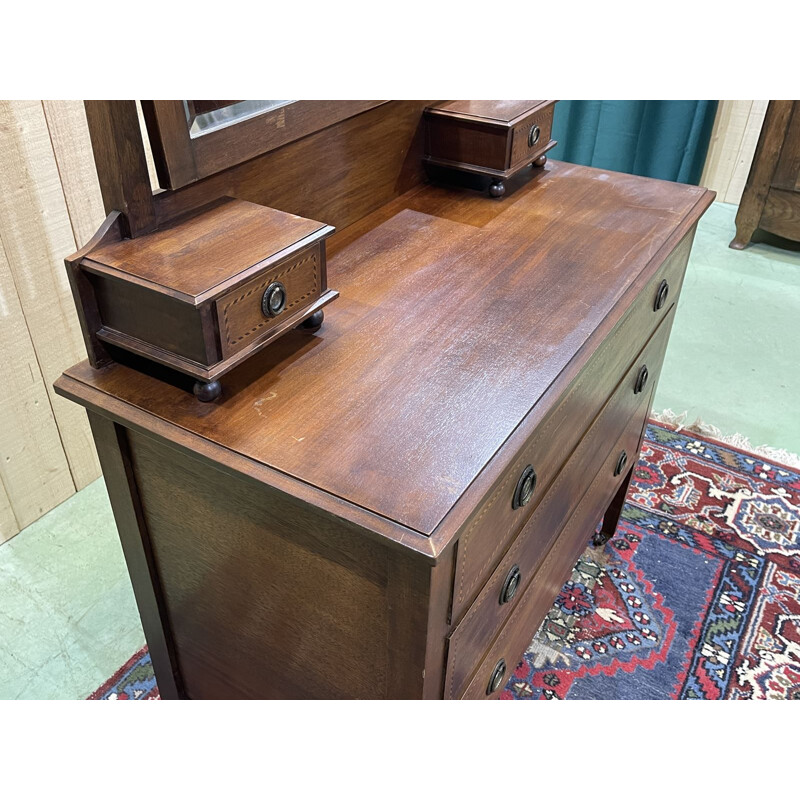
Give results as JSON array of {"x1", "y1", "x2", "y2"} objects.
[{"x1": 451, "y1": 231, "x2": 693, "y2": 621}]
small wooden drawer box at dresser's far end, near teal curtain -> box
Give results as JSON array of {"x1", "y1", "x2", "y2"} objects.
[{"x1": 425, "y1": 100, "x2": 558, "y2": 197}]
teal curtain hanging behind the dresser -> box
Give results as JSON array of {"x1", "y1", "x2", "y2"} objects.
[{"x1": 548, "y1": 100, "x2": 717, "y2": 184}]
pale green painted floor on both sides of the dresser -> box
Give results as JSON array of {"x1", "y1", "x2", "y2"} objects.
[{"x1": 0, "y1": 204, "x2": 800, "y2": 699}]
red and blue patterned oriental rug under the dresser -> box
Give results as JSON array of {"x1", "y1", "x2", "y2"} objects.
[{"x1": 89, "y1": 424, "x2": 800, "y2": 700}]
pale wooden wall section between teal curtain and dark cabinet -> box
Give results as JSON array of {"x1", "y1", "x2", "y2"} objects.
[{"x1": 700, "y1": 100, "x2": 769, "y2": 205}]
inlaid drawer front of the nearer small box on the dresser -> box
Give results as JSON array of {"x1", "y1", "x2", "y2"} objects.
[{"x1": 217, "y1": 243, "x2": 324, "y2": 358}]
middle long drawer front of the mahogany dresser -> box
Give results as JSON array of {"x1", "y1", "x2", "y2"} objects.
[{"x1": 445, "y1": 312, "x2": 674, "y2": 697}]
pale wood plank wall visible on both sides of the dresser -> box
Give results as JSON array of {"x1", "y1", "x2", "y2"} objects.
[{"x1": 0, "y1": 100, "x2": 766, "y2": 543}]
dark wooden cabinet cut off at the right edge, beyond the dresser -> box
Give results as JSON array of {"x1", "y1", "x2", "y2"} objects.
[{"x1": 730, "y1": 100, "x2": 800, "y2": 250}]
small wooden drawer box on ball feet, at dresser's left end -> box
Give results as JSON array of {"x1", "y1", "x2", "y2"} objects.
[{"x1": 68, "y1": 198, "x2": 337, "y2": 401}]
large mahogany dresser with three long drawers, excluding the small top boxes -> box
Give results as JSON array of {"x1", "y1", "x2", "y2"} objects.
[{"x1": 56, "y1": 102, "x2": 713, "y2": 698}]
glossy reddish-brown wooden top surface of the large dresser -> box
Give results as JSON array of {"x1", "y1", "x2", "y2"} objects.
[{"x1": 59, "y1": 162, "x2": 713, "y2": 535}]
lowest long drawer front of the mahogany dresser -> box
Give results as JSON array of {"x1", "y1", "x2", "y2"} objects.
[{"x1": 460, "y1": 394, "x2": 650, "y2": 700}]
